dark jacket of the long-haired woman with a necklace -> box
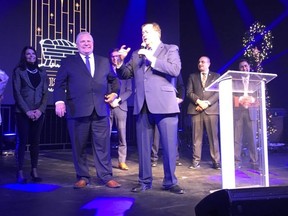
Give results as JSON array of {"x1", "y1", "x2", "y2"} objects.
[{"x1": 12, "y1": 68, "x2": 48, "y2": 113}]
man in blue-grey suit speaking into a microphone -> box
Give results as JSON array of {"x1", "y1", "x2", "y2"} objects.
[{"x1": 117, "y1": 23, "x2": 184, "y2": 194}]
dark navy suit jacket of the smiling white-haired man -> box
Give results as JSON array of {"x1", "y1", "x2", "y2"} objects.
[{"x1": 54, "y1": 53, "x2": 120, "y2": 118}]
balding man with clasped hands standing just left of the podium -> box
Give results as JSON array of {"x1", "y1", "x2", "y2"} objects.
[{"x1": 187, "y1": 56, "x2": 220, "y2": 169}]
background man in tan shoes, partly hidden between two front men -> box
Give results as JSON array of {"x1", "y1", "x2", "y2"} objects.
[{"x1": 109, "y1": 49, "x2": 132, "y2": 170}]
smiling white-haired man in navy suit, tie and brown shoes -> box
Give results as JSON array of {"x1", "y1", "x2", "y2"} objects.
[{"x1": 54, "y1": 32, "x2": 120, "y2": 189}]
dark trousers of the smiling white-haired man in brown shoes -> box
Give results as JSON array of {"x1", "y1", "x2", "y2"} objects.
[{"x1": 67, "y1": 111, "x2": 112, "y2": 184}]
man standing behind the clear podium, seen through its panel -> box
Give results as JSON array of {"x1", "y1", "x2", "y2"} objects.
[{"x1": 234, "y1": 59, "x2": 258, "y2": 169}]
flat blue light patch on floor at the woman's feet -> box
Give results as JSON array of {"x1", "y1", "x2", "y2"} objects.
[{"x1": 0, "y1": 183, "x2": 60, "y2": 193}]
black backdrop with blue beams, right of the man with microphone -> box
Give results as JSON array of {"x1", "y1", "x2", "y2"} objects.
[{"x1": 180, "y1": 0, "x2": 288, "y2": 109}]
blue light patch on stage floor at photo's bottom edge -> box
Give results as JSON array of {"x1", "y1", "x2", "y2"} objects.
[{"x1": 82, "y1": 197, "x2": 134, "y2": 216}]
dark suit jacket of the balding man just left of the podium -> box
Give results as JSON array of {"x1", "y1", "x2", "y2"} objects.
[{"x1": 187, "y1": 71, "x2": 220, "y2": 115}]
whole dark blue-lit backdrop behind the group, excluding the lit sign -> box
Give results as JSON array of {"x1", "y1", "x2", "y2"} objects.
[{"x1": 0, "y1": 0, "x2": 288, "y2": 109}]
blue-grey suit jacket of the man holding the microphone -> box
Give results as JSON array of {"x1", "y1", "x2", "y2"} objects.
[{"x1": 117, "y1": 43, "x2": 181, "y2": 115}]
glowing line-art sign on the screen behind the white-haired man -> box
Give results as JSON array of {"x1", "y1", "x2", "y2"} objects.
[{"x1": 30, "y1": 0, "x2": 91, "y2": 92}]
